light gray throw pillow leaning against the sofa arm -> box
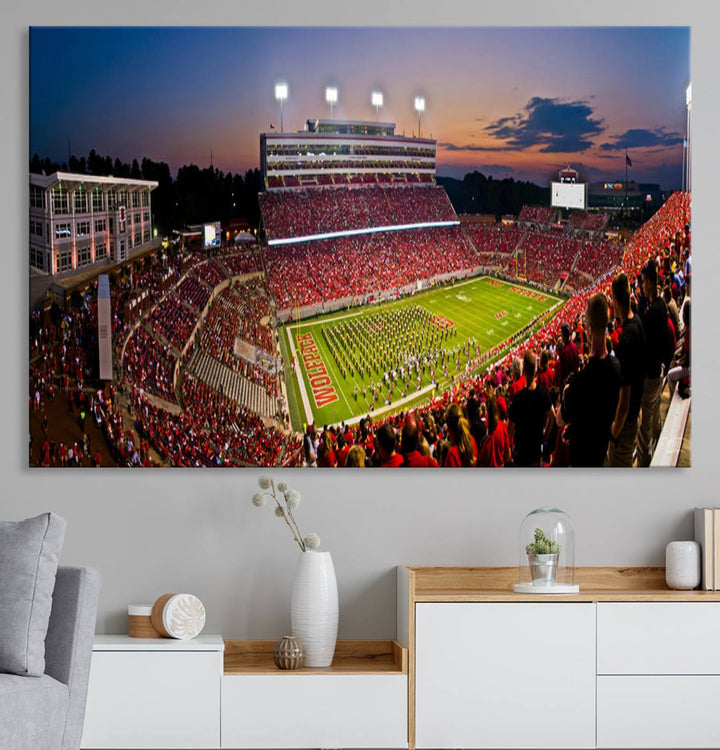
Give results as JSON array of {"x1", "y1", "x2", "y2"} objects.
[{"x1": 0, "y1": 513, "x2": 65, "y2": 677}]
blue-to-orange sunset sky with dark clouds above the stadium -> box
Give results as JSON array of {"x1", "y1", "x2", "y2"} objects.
[{"x1": 30, "y1": 27, "x2": 690, "y2": 189}]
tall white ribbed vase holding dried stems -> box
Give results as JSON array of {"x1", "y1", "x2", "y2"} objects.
[{"x1": 290, "y1": 550, "x2": 338, "y2": 667}]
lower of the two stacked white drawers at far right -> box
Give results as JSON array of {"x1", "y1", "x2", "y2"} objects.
[{"x1": 597, "y1": 675, "x2": 720, "y2": 748}]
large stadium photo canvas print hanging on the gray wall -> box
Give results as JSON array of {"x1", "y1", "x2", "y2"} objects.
[{"x1": 28, "y1": 26, "x2": 692, "y2": 469}]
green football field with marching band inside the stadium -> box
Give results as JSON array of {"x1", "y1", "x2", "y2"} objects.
[{"x1": 280, "y1": 277, "x2": 562, "y2": 430}]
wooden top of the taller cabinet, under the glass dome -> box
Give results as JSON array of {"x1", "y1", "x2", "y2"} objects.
[{"x1": 402, "y1": 566, "x2": 720, "y2": 602}]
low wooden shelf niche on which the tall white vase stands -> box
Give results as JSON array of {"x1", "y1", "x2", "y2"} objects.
[{"x1": 225, "y1": 641, "x2": 408, "y2": 675}]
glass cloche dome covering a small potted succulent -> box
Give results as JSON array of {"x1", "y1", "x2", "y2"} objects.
[{"x1": 514, "y1": 506, "x2": 580, "y2": 594}]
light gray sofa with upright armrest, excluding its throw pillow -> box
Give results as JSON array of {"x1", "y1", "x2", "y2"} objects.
[{"x1": 0, "y1": 566, "x2": 101, "y2": 750}]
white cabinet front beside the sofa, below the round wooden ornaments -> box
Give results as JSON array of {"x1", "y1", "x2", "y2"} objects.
[{"x1": 82, "y1": 650, "x2": 223, "y2": 749}]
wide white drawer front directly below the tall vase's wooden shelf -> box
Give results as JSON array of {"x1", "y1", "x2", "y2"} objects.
[{"x1": 222, "y1": 674, "x2": 407, "y2": 748}]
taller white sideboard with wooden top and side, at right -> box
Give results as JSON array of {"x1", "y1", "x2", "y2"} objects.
[{"x1": 398, "y1": 568, "x2": 720, "y2": 750}]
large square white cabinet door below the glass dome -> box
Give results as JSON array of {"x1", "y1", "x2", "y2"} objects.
[{"x1": 415, "y1": 602, "x2": 595, "y2": 750}]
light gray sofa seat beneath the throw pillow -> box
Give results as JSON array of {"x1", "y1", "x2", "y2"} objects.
[{"x1": 0, "y1": 674, "x2": 68, "y2": 750}]
